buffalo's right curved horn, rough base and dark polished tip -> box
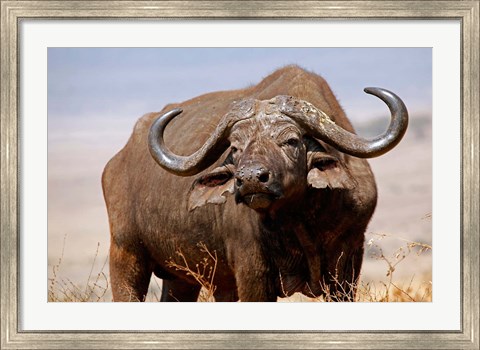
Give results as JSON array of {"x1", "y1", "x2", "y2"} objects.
[{"x1": 281, "y1": 87, "x2": 408, "y2": 158}]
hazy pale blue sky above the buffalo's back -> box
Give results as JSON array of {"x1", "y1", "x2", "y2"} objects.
[{"x1": 48, "y1": 48, "x2": 432, "y2": 132}]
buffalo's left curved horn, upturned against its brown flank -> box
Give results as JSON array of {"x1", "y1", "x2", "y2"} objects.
[{"x1": 148, "y1": 108, "x2": 231, "y2": 176}]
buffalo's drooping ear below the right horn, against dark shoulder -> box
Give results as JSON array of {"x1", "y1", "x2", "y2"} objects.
[{"x1": 307, "y1": 152, "x2": 356, "y2": 190}]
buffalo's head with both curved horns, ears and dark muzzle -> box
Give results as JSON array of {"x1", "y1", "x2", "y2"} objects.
[{"x1": 148, "y1": 88, "x2": 408, "y2": 211}]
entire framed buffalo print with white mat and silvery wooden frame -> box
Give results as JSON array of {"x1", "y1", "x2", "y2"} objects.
[{"x1": 1, "y1": 1, "x2": 480, "y2": 349}]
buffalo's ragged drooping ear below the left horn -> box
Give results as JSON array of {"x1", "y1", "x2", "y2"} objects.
[{"x1": 188, "y1": 165, "x2": 234, "y2": 211}]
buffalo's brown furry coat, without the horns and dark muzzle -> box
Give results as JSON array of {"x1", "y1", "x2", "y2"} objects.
[{"x1": 102, "y1": 66, "x2": 377, "y2": 301}]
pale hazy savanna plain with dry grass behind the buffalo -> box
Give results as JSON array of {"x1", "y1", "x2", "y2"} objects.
[{"x1": 48, "y1": 115, "x2": 433, "y2": 302}]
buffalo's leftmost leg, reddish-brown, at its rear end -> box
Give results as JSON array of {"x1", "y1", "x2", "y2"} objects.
[{"x1": 110, "y1": 242, "x2": 152, "y2": 301}]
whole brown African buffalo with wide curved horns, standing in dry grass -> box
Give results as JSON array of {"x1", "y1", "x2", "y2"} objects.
[{"x1": 102, "y1": 66, "x2": 408, "y2": 301}]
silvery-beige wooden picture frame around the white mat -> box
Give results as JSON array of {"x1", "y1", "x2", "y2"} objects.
[{"x1": 0, "y1": 1, "x2": 480, "y2": 349}]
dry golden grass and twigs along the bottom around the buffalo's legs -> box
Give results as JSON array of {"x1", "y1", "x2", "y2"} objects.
[{"x1": 48, "y1": 234, "x2": 432, "y2": 302}]
